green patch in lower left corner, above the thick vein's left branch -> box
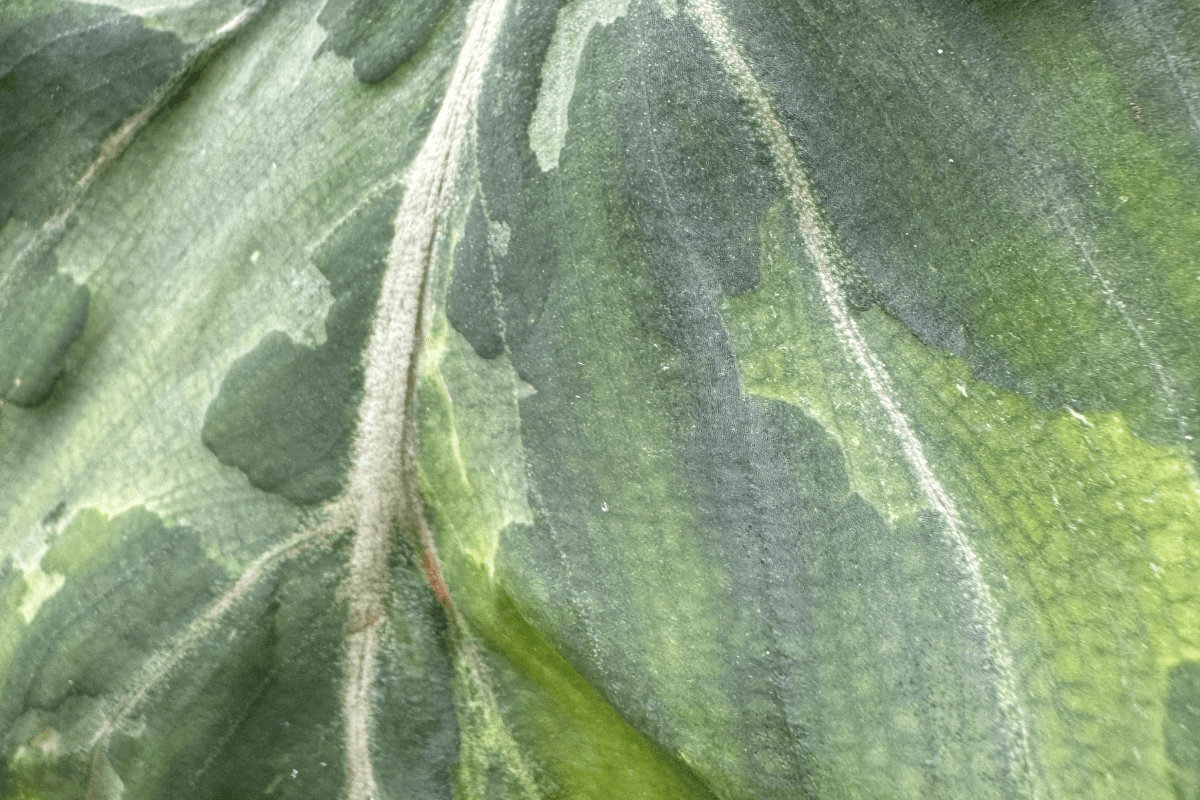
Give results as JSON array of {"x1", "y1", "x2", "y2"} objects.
[{"x1": 0, "y1": 507, "x2": 226, "y2": 796}]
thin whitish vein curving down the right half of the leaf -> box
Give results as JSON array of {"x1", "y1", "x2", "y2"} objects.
[{"x1": 689, "y1": 0, "x2": 1036, "y2": 796}]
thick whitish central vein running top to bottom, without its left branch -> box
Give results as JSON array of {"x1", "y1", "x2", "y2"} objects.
[{"x1": 337, "y1": 0, "x2": 505, "y2": 800}]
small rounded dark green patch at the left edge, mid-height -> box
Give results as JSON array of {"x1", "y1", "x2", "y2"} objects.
[{"x1": 0, "y1": 253, "x2": 90, "y2": 408}]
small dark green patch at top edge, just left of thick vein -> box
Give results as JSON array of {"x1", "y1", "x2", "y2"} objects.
[{"x1": 317, "y1": 0, "x2": 463, "y2": 83}]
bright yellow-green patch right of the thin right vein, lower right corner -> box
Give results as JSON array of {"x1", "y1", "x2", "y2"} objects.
[{"x1": 862, "y1": 312, "x2": 1200, "y2": 800}]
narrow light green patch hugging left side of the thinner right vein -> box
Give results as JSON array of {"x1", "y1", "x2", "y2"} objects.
[{"x1": 722, "y1": 200, "x2": 926, "y2": 524}]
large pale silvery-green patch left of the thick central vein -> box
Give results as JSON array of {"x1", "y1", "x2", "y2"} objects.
[{"x1": 0, "y1": 2, "x2": 455, "y2": 569}]
